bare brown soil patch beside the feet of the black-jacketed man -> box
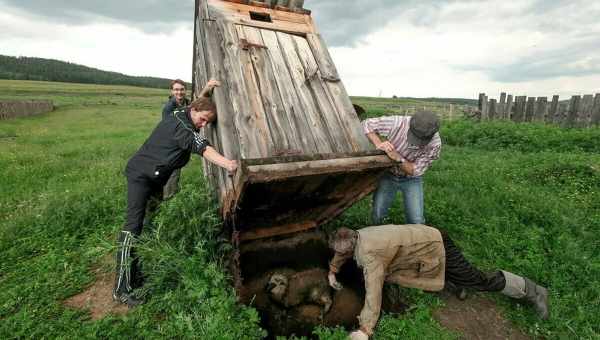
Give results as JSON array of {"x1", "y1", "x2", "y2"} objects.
[{"x1": 63, "y1": 257, "x2": 128, "y2": 321}]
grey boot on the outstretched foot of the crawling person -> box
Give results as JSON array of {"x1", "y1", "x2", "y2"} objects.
[{"x1": 502, "y1": 271, "x2": 549, "y2": 320}]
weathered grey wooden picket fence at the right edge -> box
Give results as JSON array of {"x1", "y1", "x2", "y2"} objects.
[{"x1": 476, "y1": 92, "x2": 600, "y2": 127}]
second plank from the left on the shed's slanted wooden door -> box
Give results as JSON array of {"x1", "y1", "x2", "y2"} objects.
[{"x1": 261, "y1": 30, "x2": 317, "y2": 153}]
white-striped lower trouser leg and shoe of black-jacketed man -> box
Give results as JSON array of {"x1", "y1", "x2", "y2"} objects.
[{"x1": 113, "y1": 231, "x2": 143, "y2": 308}]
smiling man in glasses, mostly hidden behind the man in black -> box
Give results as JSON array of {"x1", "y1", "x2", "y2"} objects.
[{"x1": 162, "y1": 79, "x2": 221, "y2": 200}]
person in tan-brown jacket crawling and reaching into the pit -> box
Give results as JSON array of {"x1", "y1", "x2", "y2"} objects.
[{"x1": 328, "y1": 224, "x2": 548, "y2": 339}]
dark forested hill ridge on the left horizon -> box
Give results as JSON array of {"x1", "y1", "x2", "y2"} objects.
[{"x1": 0, "y1": 55, "x2": 188, "y2": 88}]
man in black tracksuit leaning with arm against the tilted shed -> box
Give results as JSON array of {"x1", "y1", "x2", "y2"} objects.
[{"x1": 113, "y1": 79, "x2": 237, "y2": 307}]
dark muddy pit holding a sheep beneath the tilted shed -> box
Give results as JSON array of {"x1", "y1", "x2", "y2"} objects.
[{"x1": 238, "y1": 231, "x2": 406, "y2": 338}]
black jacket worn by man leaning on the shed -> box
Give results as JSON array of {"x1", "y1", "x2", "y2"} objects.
[{"x1": 125, "y1": 109, "x2": 210, "y2": 184}]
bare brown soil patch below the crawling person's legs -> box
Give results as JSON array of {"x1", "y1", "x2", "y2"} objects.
[{"x1": 433, "y1": 293, "x2": 530, "y2": 340}]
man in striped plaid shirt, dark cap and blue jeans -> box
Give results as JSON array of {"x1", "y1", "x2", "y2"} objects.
[{"x1": 363, "y1": 111, "x2": 442, "y2": 225}]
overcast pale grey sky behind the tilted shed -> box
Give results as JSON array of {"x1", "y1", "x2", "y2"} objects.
[{"x1": 0, "y1": 0, "x2": 600, "y2": 98}]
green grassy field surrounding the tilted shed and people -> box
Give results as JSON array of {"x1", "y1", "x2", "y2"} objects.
[{"x1": 0, "y1": 81, "x2": 600, "y2": 339}]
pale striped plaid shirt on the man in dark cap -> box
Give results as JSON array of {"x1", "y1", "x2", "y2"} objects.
[{"x1": 362, "y1": 116, "x2": 442, "y2": 177}]
